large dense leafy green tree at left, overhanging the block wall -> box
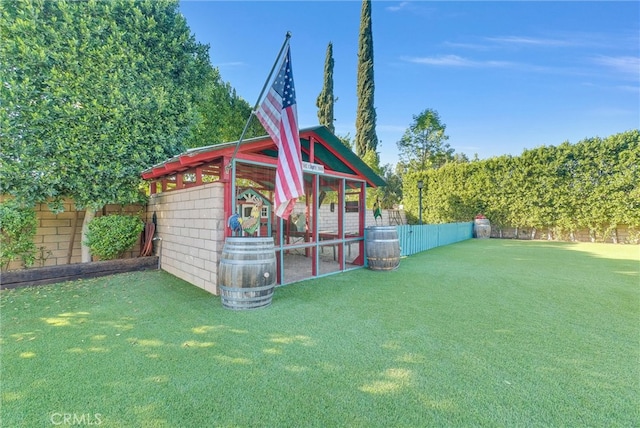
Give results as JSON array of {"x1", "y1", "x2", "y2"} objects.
[{"x1": 0, "y1": 0, "x2": 210, "y2": 261}]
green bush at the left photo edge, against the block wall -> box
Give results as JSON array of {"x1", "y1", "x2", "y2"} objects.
[{"x1": 0, "y1": 199, "x2": 38, "y2": 270}]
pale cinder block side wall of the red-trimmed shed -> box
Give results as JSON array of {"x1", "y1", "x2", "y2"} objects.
[{"x1": 147, "y1": 183, "x2": 225, "y2": 295}]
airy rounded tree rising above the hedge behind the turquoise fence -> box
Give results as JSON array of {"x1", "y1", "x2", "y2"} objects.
[{"x1": 397, "y1": 109, "x2": 454, "y2": 170}]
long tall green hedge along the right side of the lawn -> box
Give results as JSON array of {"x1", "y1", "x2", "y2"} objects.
[{"x1": 403, "y1": 130, "x2": 640, "y2": 240}]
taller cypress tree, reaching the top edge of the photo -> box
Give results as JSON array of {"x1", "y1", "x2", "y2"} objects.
[{"x1": 356, "y1": 0, "x2": 378, "y2": 156}]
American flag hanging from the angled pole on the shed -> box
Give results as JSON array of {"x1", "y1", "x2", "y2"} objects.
[{"x1": 256, "y1": 46, "x2": 304, "y2": 220}]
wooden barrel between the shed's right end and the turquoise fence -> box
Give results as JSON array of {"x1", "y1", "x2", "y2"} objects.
[{"x1": 365, "y1": 226, "x2": 400, "y2": 270}]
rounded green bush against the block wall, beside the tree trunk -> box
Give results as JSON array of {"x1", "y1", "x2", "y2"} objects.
[{"x1": 85, "y1": 215, "x2": 144, "y2": 260}]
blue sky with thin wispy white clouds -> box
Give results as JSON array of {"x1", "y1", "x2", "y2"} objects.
[{"x1": 180, "y1": 0, "x2": 640, "y2": 164}]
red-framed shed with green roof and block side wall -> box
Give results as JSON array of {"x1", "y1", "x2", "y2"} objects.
[{"x1": 142, "y1": 126, "x2": 385, "y2": 294}]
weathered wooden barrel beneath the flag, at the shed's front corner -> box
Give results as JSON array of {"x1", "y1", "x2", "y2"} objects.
[{"x1": 218, "y1": 237, "x2": 276, "y2": 310}]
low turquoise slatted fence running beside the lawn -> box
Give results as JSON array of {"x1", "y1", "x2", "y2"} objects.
[{"x1": 397, "y1": 222, "x2": 473, "y2": 256}]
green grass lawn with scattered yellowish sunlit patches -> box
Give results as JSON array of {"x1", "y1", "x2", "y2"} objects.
[{"x1": 0, "y1": 240, "x2": 640, "y2": 427}]
